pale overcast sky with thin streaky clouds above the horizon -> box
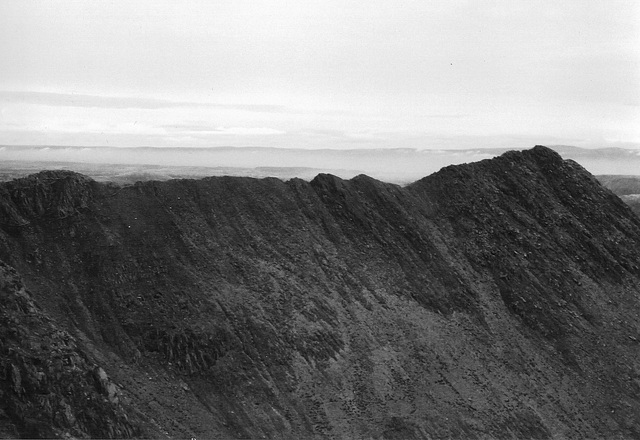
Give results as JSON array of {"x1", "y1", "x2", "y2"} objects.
[{"x1": 0, "y1": 0, "x2": 640, "y2": 148}]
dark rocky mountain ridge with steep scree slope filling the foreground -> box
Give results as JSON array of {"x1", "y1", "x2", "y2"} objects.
[{"x1": 0, "y1": 146, "x2": 640, "y2": 439}]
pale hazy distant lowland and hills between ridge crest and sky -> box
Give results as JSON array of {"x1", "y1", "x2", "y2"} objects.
[{"x1": 0, "y1": 145, "x2": 640, "y2": 185}]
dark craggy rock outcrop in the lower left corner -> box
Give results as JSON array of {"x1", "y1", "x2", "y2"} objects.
[{"x1": 0, "y1": 262, "x2": 141, "y2": 438}]
